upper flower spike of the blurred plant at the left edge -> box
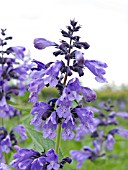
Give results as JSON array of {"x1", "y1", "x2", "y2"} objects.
[{"x1": 0, "y1": 29, "x2": 31, "y2": 118}]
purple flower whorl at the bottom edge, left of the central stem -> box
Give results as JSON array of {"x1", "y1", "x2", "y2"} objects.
[{"x1": 10, "y1": 147, "x2": 60, "y2": 170}]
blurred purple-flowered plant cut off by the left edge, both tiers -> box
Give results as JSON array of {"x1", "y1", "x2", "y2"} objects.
[{"x1": 0, "y1": 29, "x2": 31, "y2": 170}]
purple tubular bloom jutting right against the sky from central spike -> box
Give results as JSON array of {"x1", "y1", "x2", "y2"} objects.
[{"x1": 84, "y1": 60, "x2": 107, "y2": 83}]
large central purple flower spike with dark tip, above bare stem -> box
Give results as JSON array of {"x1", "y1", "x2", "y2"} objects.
[{"x1": 28, "y1": 20, "x2": 107, "y2": 140}]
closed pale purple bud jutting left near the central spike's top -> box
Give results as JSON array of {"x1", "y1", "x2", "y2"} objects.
[{"x1": 34, "y1": 38, "x2": 56, "y2": 50}]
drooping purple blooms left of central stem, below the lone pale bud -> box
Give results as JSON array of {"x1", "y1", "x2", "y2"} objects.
[{"x1": 28, "y1": 61, "x2": 62, "y2": 102}]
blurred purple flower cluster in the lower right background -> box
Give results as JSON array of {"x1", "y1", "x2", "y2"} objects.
[{"x1": 70, "y1": 100, "x2": 128, "y2": 168}]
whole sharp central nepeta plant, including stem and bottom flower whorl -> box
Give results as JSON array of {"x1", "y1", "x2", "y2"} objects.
[{"x1": 11, "y1": 20, "x2": 107, "y2": 170}]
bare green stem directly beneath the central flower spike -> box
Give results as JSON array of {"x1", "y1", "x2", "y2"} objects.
[{"x1": 55, "y1": 123, "x2": 61, "y2": 154}]
